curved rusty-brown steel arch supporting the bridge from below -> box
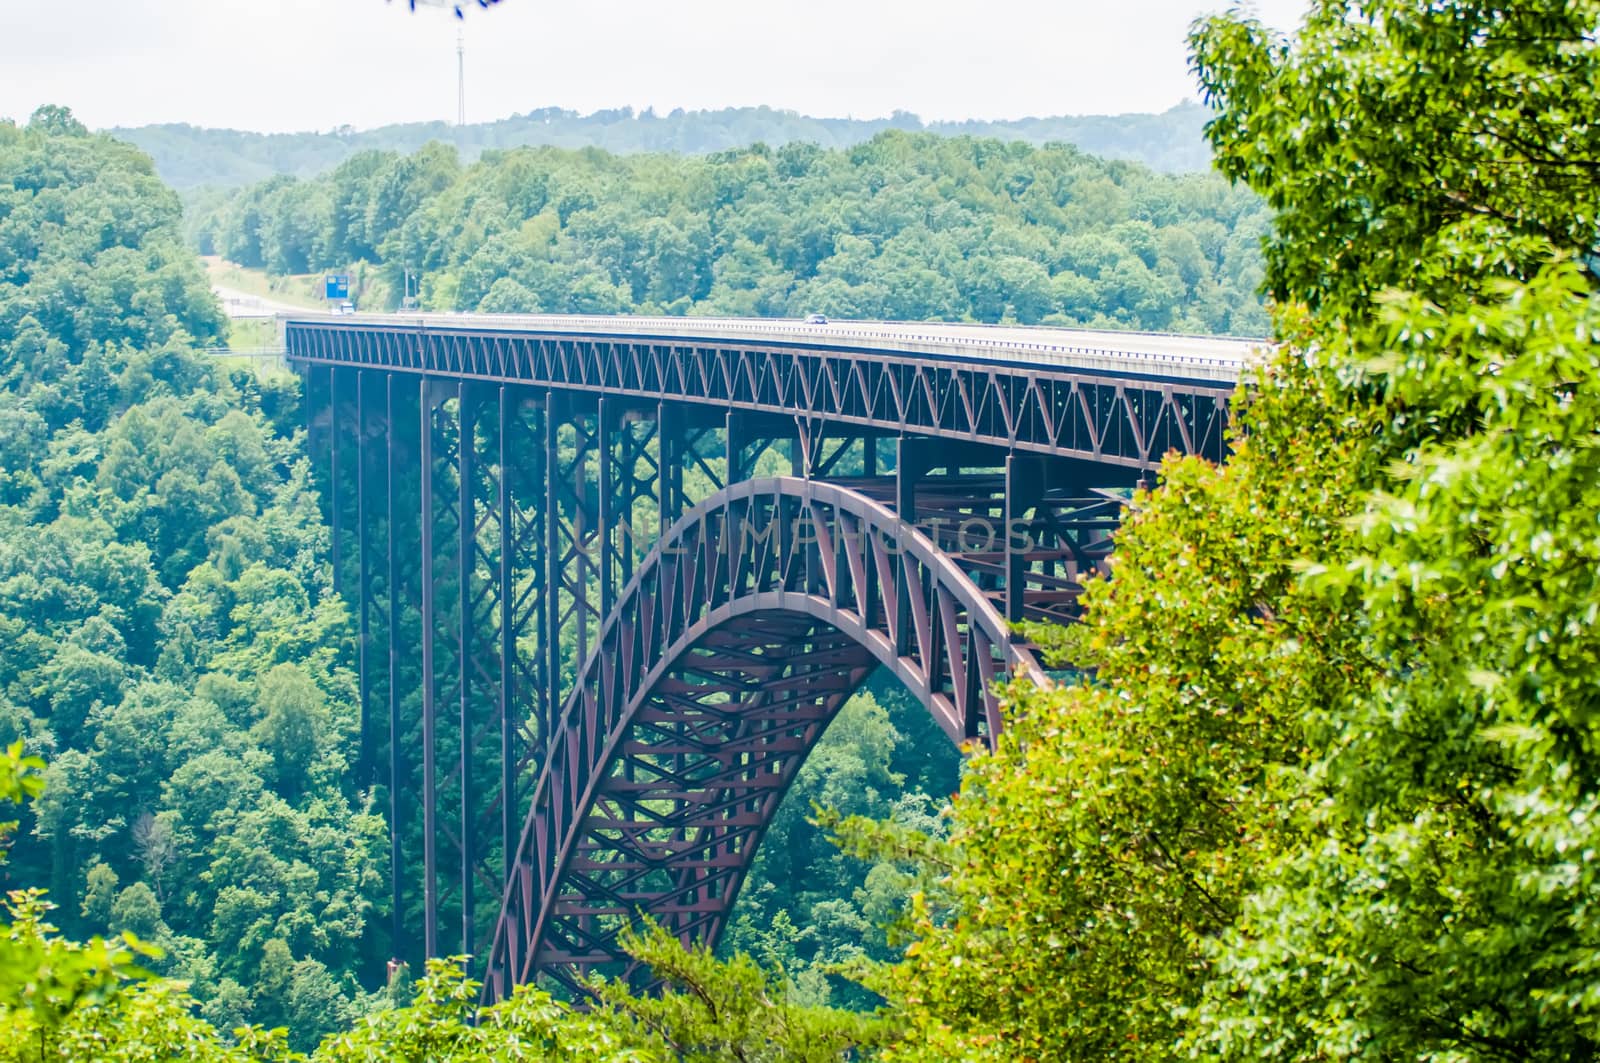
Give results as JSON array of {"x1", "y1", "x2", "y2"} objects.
[{"x1": 485, "y1": 477, "x2": 1045, "y2": 999}]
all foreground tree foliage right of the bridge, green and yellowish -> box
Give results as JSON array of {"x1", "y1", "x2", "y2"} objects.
[{"x1": 875, "y1": 0, "x2": 1600, "y2": 1060}]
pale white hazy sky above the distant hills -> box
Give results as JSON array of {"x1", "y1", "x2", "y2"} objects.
[{"x1": 0, "y1": 0, "x2": 1306, "y2": 131}]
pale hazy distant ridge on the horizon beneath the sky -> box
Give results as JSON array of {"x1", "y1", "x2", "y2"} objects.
[{"x1": 110, "y1": 102, "x2": 1211, "y2": 189}]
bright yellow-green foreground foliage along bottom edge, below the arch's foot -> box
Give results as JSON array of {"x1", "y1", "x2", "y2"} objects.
[{"x1": 0, "y1": 748, "x2": 888, "y2": 1063}]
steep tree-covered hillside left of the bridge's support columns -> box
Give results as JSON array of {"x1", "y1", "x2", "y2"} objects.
[{"x1": 0, "y1": 109, "x2": 400, "y2": 1034}]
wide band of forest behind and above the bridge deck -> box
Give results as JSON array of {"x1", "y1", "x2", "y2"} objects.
[{"x1": 189, "y1": 131, "x2": 1269, "y2": 335}]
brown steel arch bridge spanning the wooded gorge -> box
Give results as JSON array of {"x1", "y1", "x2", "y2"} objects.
[{"x1": 285, "y1": 315, "x2": 1251, "y2": 999}]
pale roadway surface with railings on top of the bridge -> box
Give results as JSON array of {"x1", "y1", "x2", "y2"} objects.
[{"x1": 285, "y1": 311, "x2": 1270, "y2": 383}]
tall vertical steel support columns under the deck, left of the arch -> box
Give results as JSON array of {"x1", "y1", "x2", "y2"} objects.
[{"x1": 320, "y1": 370, "x2": 552, "y2": 962}]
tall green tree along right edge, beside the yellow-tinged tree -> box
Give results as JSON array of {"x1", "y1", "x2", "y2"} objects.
[{"x1": 1195, "y1": 3, "x2": 1600, "y2": 1060}]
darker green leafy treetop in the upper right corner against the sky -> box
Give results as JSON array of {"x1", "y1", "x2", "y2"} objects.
[{"x1": 1192, "y1": 0, "x2": 1600, "y2": 315}]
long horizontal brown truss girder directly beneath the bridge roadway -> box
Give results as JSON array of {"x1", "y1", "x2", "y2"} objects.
[{"x1": 285, "y1": 322, "x2": 1232, "y2": 469}]
